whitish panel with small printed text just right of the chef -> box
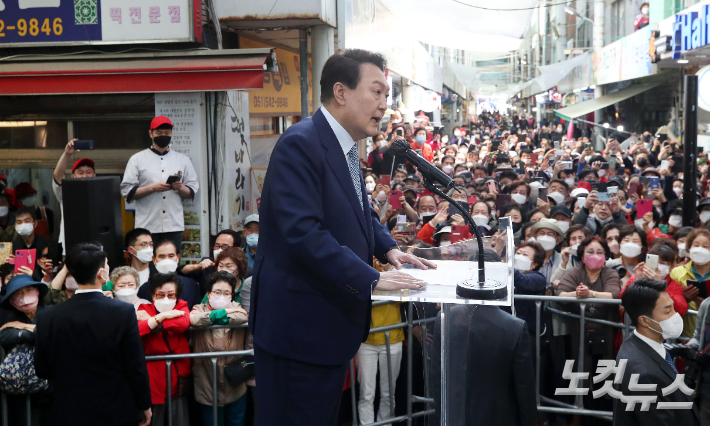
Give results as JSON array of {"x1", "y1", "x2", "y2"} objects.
[{"x1": 155, "y1": 92, "x2": 209, "y2": 262}]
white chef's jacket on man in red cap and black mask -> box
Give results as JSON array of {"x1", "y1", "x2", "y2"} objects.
[{"x1": 121, "y1": 148, "x2": 199, "y2": 233}]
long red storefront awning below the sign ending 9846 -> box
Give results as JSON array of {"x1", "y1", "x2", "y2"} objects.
[{"x1": 0, "y1": 48, "x2": 276, "y2": 95}]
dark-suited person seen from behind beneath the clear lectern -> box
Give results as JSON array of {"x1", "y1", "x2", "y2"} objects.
[{"x1": 430, "y1": 250, "x2": 537, "y2": 426}]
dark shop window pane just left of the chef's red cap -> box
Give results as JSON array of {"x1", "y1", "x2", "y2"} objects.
[{"x1": 73, "y1": 120, "x2": 152, "y2": 149}]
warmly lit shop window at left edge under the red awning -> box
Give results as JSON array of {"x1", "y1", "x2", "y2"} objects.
[{"x1": 0, "y1": 121, "x2": 68, "y2": 149}]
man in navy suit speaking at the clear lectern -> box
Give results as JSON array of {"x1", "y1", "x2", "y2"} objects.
[{"x1": 249, "y1": 50, "x2": 434, "y2": 426}]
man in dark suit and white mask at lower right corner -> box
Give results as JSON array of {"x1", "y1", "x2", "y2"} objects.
[{"x1": 614, "y1": 278, "x2": 700, "y2": 426}]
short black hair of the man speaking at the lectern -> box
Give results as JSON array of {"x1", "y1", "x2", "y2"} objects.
[{"x1": 320, "y1": 49, "x2": 387, "y2": 104}]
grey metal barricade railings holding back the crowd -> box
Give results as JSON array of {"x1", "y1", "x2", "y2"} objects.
[{"x1": 0, "y1": 294, "x2": 697, "y2": 426}]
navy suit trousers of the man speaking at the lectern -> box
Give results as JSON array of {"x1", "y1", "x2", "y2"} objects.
[{"x1": 254, "y1": 345, "x2": 348, "y2": 426}]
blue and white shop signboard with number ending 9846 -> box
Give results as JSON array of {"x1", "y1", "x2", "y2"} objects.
[{"x1": 0, "y1": 0, "x2": 197, "y2": 47}]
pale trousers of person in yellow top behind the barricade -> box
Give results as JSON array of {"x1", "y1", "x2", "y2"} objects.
[{"x1": 355, "y1": 342, "x2": 402, "y2": 425}]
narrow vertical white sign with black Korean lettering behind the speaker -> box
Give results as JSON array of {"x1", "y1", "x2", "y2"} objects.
[{"x1": 222, "y1": 90, "x2": 253, "y2": 231}]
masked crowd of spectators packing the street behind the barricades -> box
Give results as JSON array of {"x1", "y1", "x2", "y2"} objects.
[{"x1": 0, "y1": 102, "x2": 710, "y2": 425}]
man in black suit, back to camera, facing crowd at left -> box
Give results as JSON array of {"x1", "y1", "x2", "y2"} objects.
[{"x1": 35, "y1": 244, "x2": 152, "y2": 426}]
